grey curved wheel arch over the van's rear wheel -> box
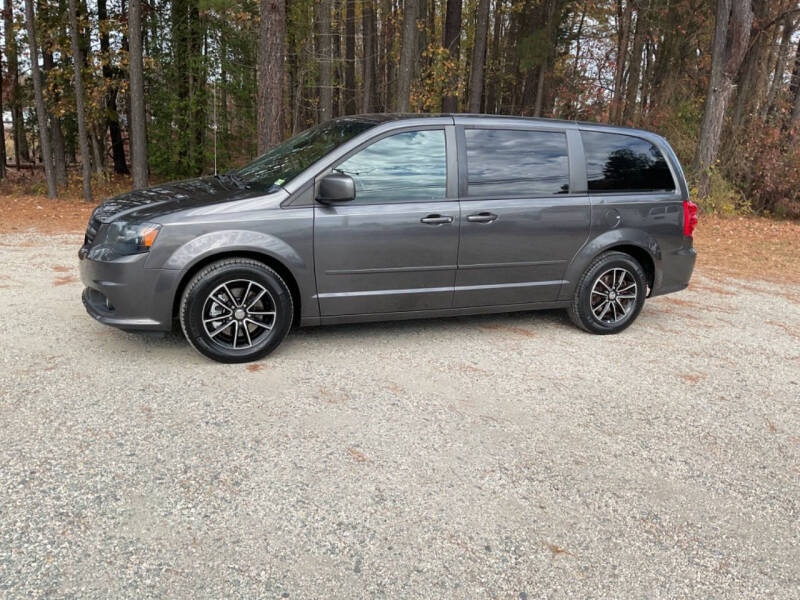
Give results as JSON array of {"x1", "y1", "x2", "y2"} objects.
[{"x1": 559, "y1": 227, "x2": 663, "y2": 300}]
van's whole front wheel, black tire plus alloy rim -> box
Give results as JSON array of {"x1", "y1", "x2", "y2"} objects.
[{"x1": 179, "y1": 258, "x2": 294, "y2": 363}]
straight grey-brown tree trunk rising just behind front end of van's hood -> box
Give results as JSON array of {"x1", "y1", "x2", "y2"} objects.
[{"x1": 129, "y1": 0, "x2": 147, "y2": 190}]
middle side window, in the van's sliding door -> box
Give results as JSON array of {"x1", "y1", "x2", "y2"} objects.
[{"x1": 464, "y1": 129, "x2": 569, "y2": 196}]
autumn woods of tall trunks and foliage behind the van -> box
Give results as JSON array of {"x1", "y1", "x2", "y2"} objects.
[{"x1": 0, "y1": 0, "x2": 800, "y2": 217}]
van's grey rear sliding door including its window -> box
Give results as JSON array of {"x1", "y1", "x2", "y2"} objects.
[{"x1": 454, "y1": 127, "x2": 590, "y2": 307}]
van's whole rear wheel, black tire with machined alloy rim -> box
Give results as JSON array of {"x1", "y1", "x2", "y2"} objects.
[{"x1": 567, "y1": 252, "x2": 647, "y2": 335}]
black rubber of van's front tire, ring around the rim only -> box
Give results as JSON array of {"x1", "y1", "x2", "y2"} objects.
[{"x1": 181, "y1": 263, "x2": 294, "y2": 363}]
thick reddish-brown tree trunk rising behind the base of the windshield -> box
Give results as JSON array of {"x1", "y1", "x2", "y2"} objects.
[{"x1": 258, "y1": 0, "x2": 286, "y2": 154}]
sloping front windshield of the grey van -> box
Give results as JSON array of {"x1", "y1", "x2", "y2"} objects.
[{"x1": 235, "y1": 119, "x2": 376, "y2": 190}]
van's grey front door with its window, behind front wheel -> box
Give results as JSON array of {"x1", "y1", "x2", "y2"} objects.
[{"x1": 314, "y1": 127, "x2": 459, "y2": 317}]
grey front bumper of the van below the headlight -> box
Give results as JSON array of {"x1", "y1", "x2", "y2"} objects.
[{"x1": 78, "y1": 249, "x2": 180, "y2": 331}]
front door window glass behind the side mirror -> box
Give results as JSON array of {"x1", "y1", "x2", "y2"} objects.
[{"x1": 335, "y1": 129, "x2": 447, "y2": 204}]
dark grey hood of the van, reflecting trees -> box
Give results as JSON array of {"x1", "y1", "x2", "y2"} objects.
[{"x1": 93, "y1": 177, "x2": 264, "y2": 223}]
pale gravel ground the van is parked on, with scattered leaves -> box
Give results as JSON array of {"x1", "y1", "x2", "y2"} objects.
[{"x1": 0, "y1": 234, "x2": 800, "y2": 599}]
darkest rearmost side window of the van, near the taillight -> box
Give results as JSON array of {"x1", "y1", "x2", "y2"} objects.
[{"x1": 581, "y1": 131, "x2": 675, "y2": 192}]
